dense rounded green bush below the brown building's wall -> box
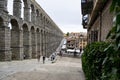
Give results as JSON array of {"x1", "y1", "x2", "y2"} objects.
[{"x1": 82, "y1": 42, "x2": 120, "y2": 80}]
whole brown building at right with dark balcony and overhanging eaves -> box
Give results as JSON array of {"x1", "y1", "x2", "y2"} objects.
[{"x1": 81, "y1": 0, "x2": 114, "y2": 43}]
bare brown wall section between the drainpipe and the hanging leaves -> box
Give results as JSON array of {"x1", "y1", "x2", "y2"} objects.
[{"x1": 101, "y1": 3, "x2": 114, "y2": 41}]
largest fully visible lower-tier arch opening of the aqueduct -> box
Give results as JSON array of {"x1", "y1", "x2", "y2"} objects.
[{"x1": 10, "y1": 19, "x2": 22, "y2": 60}]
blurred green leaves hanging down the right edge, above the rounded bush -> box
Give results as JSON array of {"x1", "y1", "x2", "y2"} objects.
[{"x1": 107, "y1": 0, "x2": 120, "y2": 51}]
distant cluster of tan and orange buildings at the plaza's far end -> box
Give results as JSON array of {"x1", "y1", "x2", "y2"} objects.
[{"x1": 66, "y1": 32, "x2": 87, "y2": 49}]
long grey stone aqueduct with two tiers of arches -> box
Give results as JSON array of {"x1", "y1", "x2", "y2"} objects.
[{"x1": 0, "y1": 0, "x2": 63, "y2": 61}]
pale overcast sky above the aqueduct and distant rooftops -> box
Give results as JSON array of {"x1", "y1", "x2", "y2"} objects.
[{"x1": 8, "y1": 0, "x2": 87, "y2": 33}]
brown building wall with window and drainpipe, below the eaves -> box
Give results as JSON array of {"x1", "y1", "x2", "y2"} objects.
[{"x1": 88, "y1": 1, "x2": 114, "y2": 42}]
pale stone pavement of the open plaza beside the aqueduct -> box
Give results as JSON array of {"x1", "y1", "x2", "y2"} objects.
[{"x1": 0, "y1": 57, "x2": 85, "y2": 80}]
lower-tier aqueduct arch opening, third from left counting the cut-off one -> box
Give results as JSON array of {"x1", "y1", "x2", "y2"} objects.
[{"x1": 22, "y1": 23, "x2": 31, "y2": 59}]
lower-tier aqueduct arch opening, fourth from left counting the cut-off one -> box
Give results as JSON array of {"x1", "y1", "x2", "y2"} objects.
[{"x1": 30, "y1": 26, "x2": 37, "y2": 58}]
